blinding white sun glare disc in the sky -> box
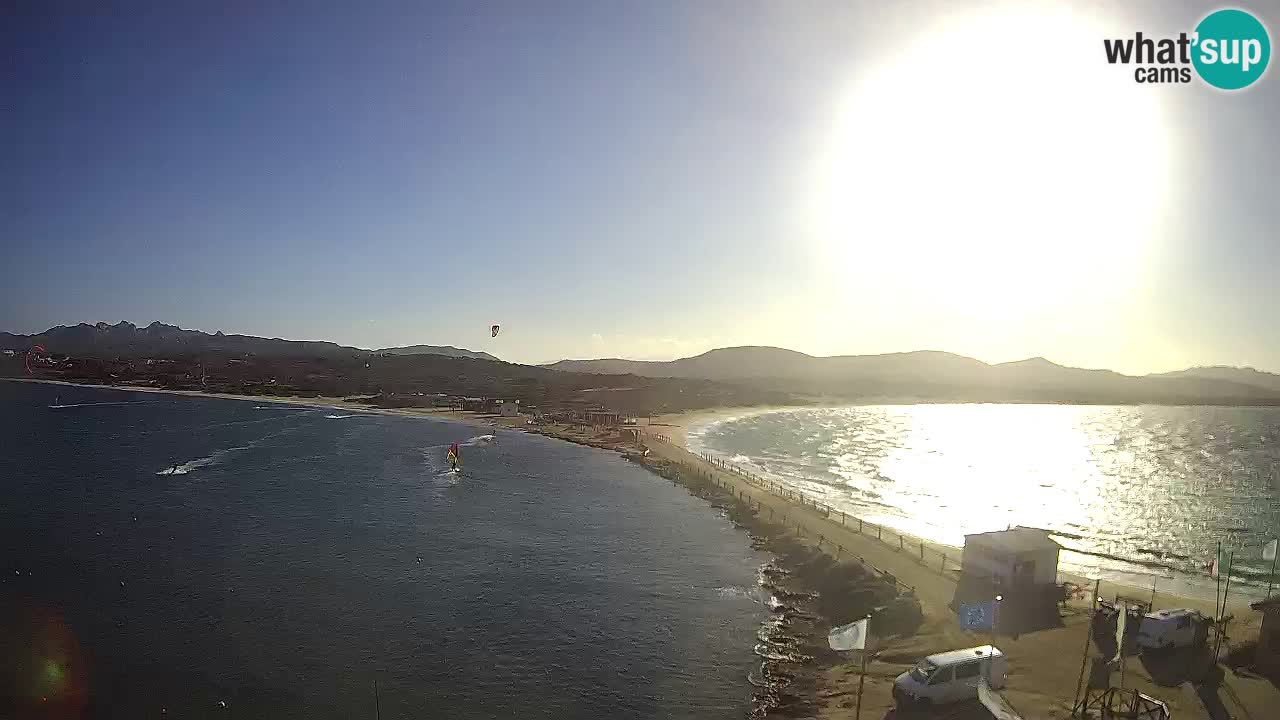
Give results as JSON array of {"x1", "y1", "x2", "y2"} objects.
[{"x1": 805, "y1": 5, "x2": 1174, "y2": 324}]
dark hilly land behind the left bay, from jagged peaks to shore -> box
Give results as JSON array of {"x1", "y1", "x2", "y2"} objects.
[{"x1": 0, "y1": 317, "x2": 800, "y2": 414}]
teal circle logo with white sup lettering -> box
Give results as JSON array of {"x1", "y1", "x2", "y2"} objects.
[{"x1": 1192, "y1": 9, "x2": 1271, "y2": 90}]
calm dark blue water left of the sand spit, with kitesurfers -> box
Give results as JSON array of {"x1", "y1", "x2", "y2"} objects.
[{"x1": 0, "y1": 382, "x2": 765, "y2": 719}]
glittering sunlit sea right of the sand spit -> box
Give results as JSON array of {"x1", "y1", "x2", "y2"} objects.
[{"x1": 687, "y1": 405, "x2": 1280, "y2": 598}]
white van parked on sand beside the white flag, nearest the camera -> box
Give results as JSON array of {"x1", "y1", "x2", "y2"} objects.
[{"x1": 893, "y1": 644, "x2": 1009, "y2": 705}]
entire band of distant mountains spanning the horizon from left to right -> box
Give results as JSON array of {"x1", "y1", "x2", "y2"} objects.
[{"x1": 0, "y1": 322, "x2": 1280, "y2": 405}]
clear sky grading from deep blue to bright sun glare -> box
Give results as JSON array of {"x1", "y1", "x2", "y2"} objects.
[{"x1": 0, "y1": 0, "x2": 1280, "y2": 373}]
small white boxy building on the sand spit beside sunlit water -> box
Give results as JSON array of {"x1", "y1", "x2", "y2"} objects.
[{"x1": 960, "y1": 528, "x2": 1062, "y2": 588}]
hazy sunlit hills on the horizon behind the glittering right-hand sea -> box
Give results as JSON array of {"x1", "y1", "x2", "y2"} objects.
[{"x1": 549, "y1": 347, "x2": 1280, "y2": 405}]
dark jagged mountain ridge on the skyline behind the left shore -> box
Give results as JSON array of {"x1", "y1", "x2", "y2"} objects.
[{"x1": 0, "y1": 322, "x2": 498, "y2": 360}]
